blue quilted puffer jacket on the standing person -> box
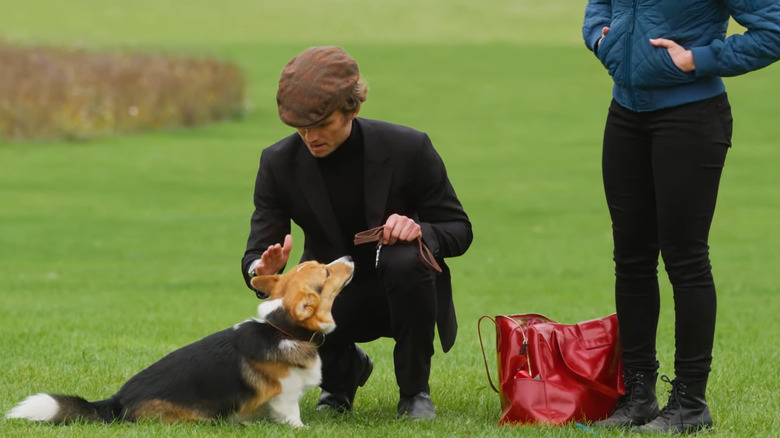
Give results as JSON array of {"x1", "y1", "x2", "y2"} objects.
[{"x1": 582, "y1": 0, "x2": 780, "y2": 112}]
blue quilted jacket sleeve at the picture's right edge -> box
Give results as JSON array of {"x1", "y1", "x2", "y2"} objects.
[{"x1": 691, "y1": 0, "x2": 780, "y2": 77}]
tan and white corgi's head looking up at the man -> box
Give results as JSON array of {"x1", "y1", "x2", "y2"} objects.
[{"x1": 252, "y1": 256, "x2": 355, "y2": 333}]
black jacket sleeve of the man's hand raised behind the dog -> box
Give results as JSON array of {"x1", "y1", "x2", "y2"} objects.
[{"x1": 241, "y1": 149, "x2": 290, "y2": 291}]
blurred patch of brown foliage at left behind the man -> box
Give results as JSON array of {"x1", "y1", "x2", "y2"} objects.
[{"x1": 0, "y1": 41, "x2": 245, "y2": 139}]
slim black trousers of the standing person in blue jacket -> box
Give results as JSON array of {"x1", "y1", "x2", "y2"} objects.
[{"x1": 602, "y1": 94, "x2": 732, "y2": 380}]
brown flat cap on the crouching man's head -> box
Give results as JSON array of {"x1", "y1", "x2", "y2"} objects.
[{"x1": 276, "y1": 46, "x2": 360, "y2": 128}]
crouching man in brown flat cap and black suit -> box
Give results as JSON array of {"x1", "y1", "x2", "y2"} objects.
[{"x1": 242, "y1": 47, "x2": 472, "y2": 419}]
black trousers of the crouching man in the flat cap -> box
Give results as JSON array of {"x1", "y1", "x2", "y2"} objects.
[{"x1": 320, "y1": 243, "x2": 436, "y2": 396}]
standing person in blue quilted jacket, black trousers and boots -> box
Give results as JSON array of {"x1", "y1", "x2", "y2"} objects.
[{"x1": 582, "y1": 0, "x2": 780, "y2": 433}]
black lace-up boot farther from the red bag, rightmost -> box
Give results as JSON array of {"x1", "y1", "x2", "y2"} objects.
[{"x1": 634, "y1": 376, "x2": 712, "y2": 433}]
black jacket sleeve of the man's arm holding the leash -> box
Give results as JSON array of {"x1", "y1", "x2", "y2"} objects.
[{"x1": 414, "y1": 135, "x2": 473, "y2": 259}]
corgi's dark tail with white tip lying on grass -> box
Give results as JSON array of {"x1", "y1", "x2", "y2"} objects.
[{"x1": 5, "y1": 394, "x2": 121, "y2": 423}]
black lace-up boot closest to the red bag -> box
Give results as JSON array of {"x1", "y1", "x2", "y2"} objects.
[{"x1": 593, "y1": 370, "x2": 658, "y2": 428}]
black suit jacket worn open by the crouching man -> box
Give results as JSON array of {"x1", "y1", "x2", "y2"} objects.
[{"x1": 241, "y1": 118, "x2": 472, "y2": 352}]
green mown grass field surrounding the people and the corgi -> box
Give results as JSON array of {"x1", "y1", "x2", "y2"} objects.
[{"x1": 0, "y1": 0, "x2": 780, "y2": 437}]
